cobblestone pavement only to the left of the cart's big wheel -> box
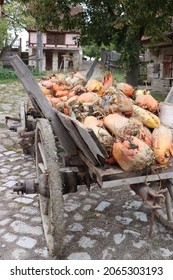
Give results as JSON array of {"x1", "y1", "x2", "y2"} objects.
[{"x1": 0, "y1": 83, "x2": 48, "y2": 260}]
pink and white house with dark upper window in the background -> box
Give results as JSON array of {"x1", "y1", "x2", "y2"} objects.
[{"x1": 28, "y1": 29, "x2": 82, "y2": 71}]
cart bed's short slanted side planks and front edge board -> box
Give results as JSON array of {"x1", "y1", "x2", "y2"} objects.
[{"x1": 56, "y1": 111, "x2": 173, "y2": 188}]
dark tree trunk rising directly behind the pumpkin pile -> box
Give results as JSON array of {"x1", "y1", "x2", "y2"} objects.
[{"x1": 126, "y1": 52, "x2": 140, "y2": 87}]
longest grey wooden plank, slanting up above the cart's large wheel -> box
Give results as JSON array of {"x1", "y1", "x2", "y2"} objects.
[{"x1": 11, "y1": 55, "x2": 78, "y2": 155}]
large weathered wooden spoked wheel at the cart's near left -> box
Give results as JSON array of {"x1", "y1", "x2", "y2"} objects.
[{"x1": 35, "y1": 118, "x2": 64, "y2": 257}]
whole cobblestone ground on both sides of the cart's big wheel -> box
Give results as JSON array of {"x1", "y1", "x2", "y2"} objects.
[{"x1": 0, "y1": 77, "x2": 173, "y2": 260}]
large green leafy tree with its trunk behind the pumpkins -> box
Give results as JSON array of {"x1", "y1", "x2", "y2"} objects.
[{"x1": 18, "y1": 0, "x2": 173, "y2": 85}]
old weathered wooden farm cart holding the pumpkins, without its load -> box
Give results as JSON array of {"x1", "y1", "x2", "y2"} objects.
[{"x1": 7, "y1": 55, "x2": 173, "y2": 257}]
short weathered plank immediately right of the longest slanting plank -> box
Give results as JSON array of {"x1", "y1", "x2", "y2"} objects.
[{"x1": 57, "y1": 111, "x2": 100, "y2": 165}]
